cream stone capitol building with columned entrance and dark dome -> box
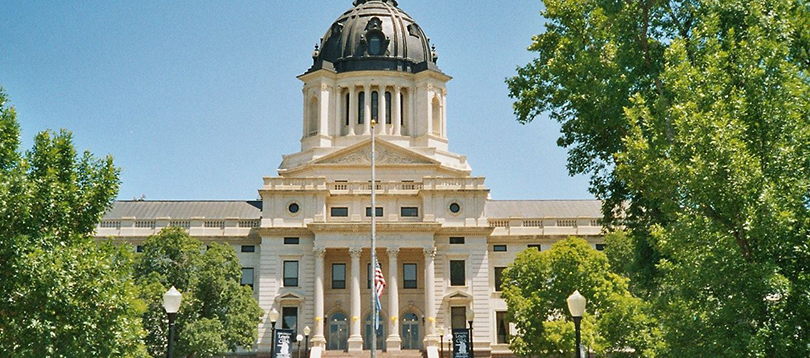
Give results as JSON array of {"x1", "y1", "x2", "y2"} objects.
[{"x1": 96, "y1": 0, "x2": 602, "y2": 358}]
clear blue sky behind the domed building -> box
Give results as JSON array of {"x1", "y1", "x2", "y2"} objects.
[{"x1": 0, "y1": 0, "x2": 592, "y2": 200}]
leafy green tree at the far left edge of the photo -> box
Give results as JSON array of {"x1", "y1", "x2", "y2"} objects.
[{"x1": 0, "y1": 90, "x2": 145, "y2": 358}]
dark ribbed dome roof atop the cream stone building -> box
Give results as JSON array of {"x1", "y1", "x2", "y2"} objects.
[{"x1": 307, "y1": 0, "x2": 439, "y2": 73}]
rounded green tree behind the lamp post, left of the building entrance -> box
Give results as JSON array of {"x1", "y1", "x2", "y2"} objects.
[{"x1": 135, "y1": 227, "x2": 264, "y2": 357}]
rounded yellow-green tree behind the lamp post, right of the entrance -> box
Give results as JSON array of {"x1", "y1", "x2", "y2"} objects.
[{"x1": 502, "y1": 237, "x2": 658, "y2": 357}]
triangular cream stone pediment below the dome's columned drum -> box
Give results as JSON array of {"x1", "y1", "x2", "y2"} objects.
[{"x1": 313, "y1": 140, "x2": 439, "y2": 166}]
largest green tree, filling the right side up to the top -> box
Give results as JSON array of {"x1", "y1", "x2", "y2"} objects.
[{"x1": 508, "y1": 0, "x2": 810, "y2": 357}]
